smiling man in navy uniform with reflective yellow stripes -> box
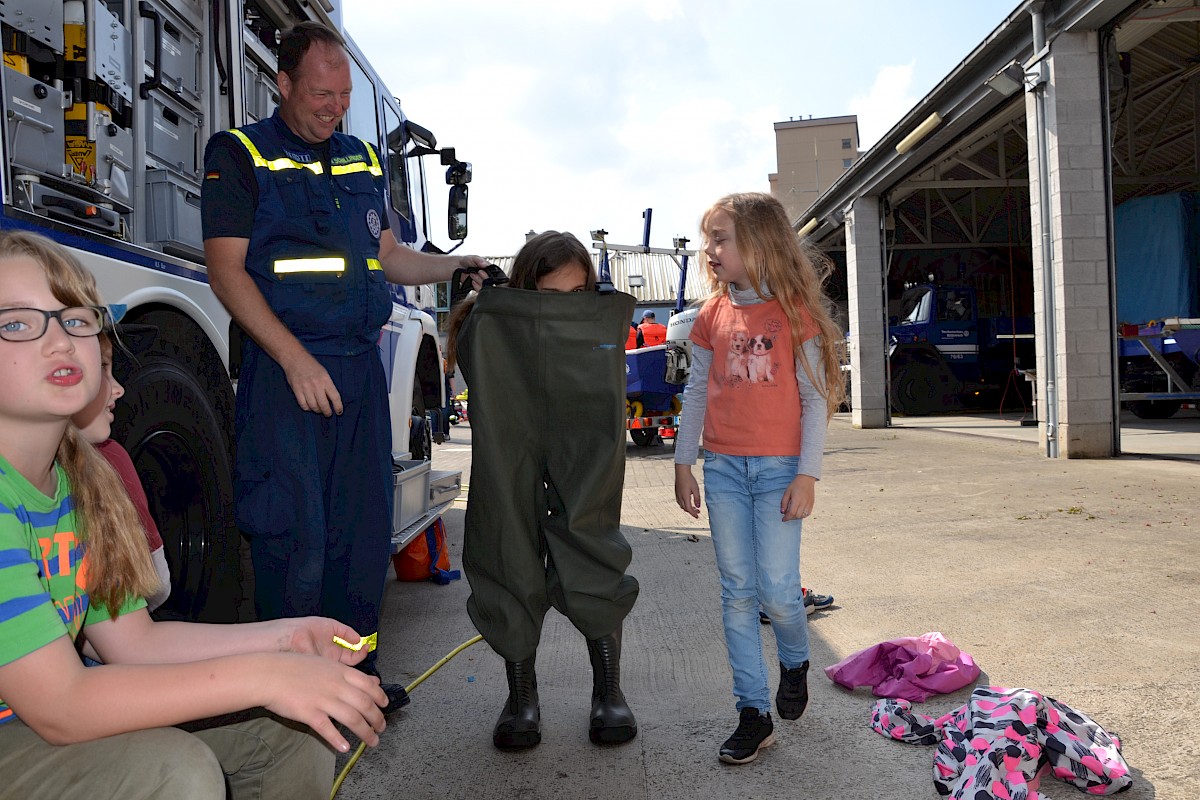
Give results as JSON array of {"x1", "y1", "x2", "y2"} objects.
[{"x1": 202, "y1": 23, "x2": 486, "y2": 705}]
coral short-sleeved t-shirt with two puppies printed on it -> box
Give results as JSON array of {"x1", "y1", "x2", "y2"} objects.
[{"x1": 690, "y1": 296, "x2": 817, "y2": 456}]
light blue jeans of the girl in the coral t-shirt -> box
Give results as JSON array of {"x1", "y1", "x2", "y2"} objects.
[{"x1": 704, "y1": 450, "x2": 809, "y2": 711}]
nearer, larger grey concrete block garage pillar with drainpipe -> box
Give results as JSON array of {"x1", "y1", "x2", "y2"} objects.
[{"x1": 1026, "y1": 31, "x2": 1116, "y2": 458}]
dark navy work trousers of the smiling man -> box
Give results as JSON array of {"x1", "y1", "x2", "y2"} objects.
[{"x1": 234, "y1": 343, "x2": 392, "y2": 655}]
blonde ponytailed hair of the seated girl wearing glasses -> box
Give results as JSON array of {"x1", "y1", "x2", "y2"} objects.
[{"x1": 0, "y1": 231, "x2": 160, "y2": 614}]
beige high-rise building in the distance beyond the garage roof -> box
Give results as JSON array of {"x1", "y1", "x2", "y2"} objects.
[{"x1": 767, "y1": 114, "x2": 858, "y2": 223}]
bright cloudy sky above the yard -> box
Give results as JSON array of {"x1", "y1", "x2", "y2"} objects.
[{"x1": 343, "y1": 0, "x2": 1019, "y2": 255}]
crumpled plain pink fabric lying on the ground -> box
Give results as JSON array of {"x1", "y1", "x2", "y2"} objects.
[{"x1": 824, "y1": 632, "x2": 979, "y2": 703}]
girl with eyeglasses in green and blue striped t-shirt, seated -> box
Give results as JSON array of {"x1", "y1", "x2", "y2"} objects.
[{"x1": 0, "y1": 231, "x2": 386, "y2": 800}]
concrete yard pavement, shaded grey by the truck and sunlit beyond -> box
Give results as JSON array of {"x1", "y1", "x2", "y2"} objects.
[{"x1": 338, "y1": 417, "x2": 1200, "y2": 800}]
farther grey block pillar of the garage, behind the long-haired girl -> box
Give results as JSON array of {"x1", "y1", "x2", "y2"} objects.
[{"x1": 846, "y1": 197, "x2": 888, "y2": 428}]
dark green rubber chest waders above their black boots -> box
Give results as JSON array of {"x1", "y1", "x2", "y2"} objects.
[{"x1": 457, "y1": 287, "x2": 637, "y2": 662}]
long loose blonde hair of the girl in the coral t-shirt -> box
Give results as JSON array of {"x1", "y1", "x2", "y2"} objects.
[{"x1": 700, "y1": 192, "x2": 846, "y2": 417}]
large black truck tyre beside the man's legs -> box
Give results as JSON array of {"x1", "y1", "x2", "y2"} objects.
[{"x1": 113, "y1": 352, "x2": 241, "y2": 622}]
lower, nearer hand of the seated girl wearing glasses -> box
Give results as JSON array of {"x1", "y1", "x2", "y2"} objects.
[{"x1": 262, "y1": 652, "x2": 388, "y2": 753}]
